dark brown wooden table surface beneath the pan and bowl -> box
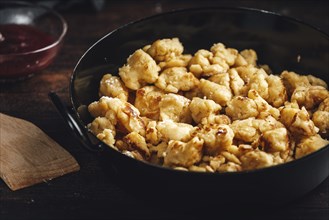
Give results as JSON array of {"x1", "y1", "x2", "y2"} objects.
[{"x1": 0, "y1": 0, "x2": 329, "y2": 220}]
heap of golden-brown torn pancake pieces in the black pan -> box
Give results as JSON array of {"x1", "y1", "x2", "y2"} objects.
[{"x1": 88, "y1": 38, "x2": 329, "y2": 172}]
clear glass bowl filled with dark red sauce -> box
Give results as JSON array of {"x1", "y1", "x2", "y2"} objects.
[{"x1": 0, "y1": 1, "x2": 67, "y2": 82}]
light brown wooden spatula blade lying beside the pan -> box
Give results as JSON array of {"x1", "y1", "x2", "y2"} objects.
[{"x1": 0, "y1": 113, "x2": 80, "y2": 190}]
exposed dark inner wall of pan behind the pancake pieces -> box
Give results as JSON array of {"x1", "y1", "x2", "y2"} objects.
[{"x1": 71, "y1": 8, "x2": 329, "y2": 125}]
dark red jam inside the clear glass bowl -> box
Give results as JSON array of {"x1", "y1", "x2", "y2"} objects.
[{"x1": 0, "y1": 24, "x2": 59, "y2": 79}]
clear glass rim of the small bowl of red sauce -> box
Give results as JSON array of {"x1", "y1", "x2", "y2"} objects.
[{"x1": 0, "y1": 1, "x2": 68, "y2": 57}]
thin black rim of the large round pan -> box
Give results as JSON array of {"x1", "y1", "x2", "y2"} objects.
[{"x1": 69, "y1": 6, "x2": 329, "y2": 176}]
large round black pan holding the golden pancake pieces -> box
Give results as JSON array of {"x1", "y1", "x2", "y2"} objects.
[{"x1": 50, "y1": 8, "x2": 329, "y2": 204}]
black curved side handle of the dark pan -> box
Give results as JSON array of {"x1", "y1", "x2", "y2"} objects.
[{"x1": 48, "y1": 91, "x2": 103, "y2": 152}]
